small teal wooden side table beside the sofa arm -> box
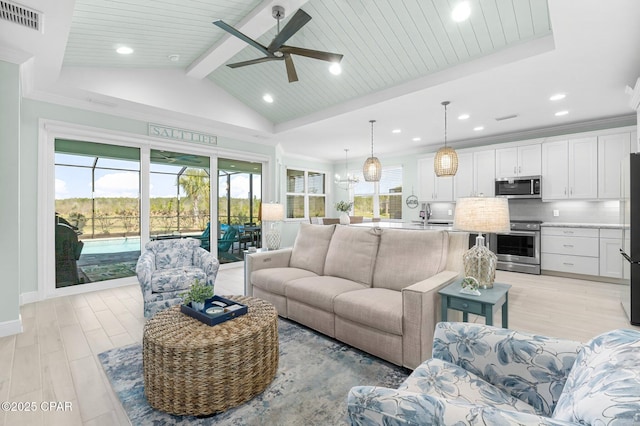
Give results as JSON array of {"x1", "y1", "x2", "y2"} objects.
[{"x1": 438, "y1": 280, "x2": 511, "y2": 328}]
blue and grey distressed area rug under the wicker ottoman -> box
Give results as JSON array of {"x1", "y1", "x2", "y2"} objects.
[{"x1": 98, "y1": 319, "x2": 410, "y2": 426}]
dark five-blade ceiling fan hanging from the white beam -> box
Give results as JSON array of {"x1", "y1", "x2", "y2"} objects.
[{"x1": 213, "y1": 6, "x2": 343, "y2": 83}]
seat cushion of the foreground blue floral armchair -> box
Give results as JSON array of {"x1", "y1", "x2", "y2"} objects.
[{"x1": 398, "y1": 358, "x2": 536, "y2": 414}]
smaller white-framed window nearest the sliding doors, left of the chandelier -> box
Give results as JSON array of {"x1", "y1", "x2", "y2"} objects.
[{"x1": 287, "y1": 169, "x2": 326, "y2": 219}]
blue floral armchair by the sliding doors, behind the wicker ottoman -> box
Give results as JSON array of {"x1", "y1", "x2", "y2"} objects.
[{"x1": 136, "y1": 238, "x2": 220, "y2": 318}]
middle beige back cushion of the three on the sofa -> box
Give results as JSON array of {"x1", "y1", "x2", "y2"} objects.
[{"x1": 324, "y1": 226, "x2": 380, "y2": 287}]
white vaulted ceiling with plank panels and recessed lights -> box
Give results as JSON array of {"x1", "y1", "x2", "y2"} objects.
[{"x1": 0, "y1": 0, "x2": 640, "y2": 163}]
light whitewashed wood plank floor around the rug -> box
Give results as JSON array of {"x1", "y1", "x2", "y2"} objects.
[{"x1": 0, "y1": 265, "x2": 640, "y2": 426}]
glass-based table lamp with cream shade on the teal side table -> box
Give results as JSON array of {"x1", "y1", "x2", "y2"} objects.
[{"x1": 453, "y1": 197, "x2": 510, "y2": 288}]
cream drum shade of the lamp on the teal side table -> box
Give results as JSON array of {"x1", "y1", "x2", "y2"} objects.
[{"x1": 453, "y1": 197, "x2": 511, "y2": 234}]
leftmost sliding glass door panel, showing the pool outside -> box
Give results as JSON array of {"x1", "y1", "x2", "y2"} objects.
[{"x1": 55, "y1": 140, "x2": 140, "y2": 288}]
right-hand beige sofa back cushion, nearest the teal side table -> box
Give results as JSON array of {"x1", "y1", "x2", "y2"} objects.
[{"x1": 373, "y1": 229, "x2": 449, "y2": 291}]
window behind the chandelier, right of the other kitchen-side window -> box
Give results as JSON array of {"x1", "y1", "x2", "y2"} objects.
[{"x1": 353, "y1": 166, "x2": 402, "y2": 219}]
